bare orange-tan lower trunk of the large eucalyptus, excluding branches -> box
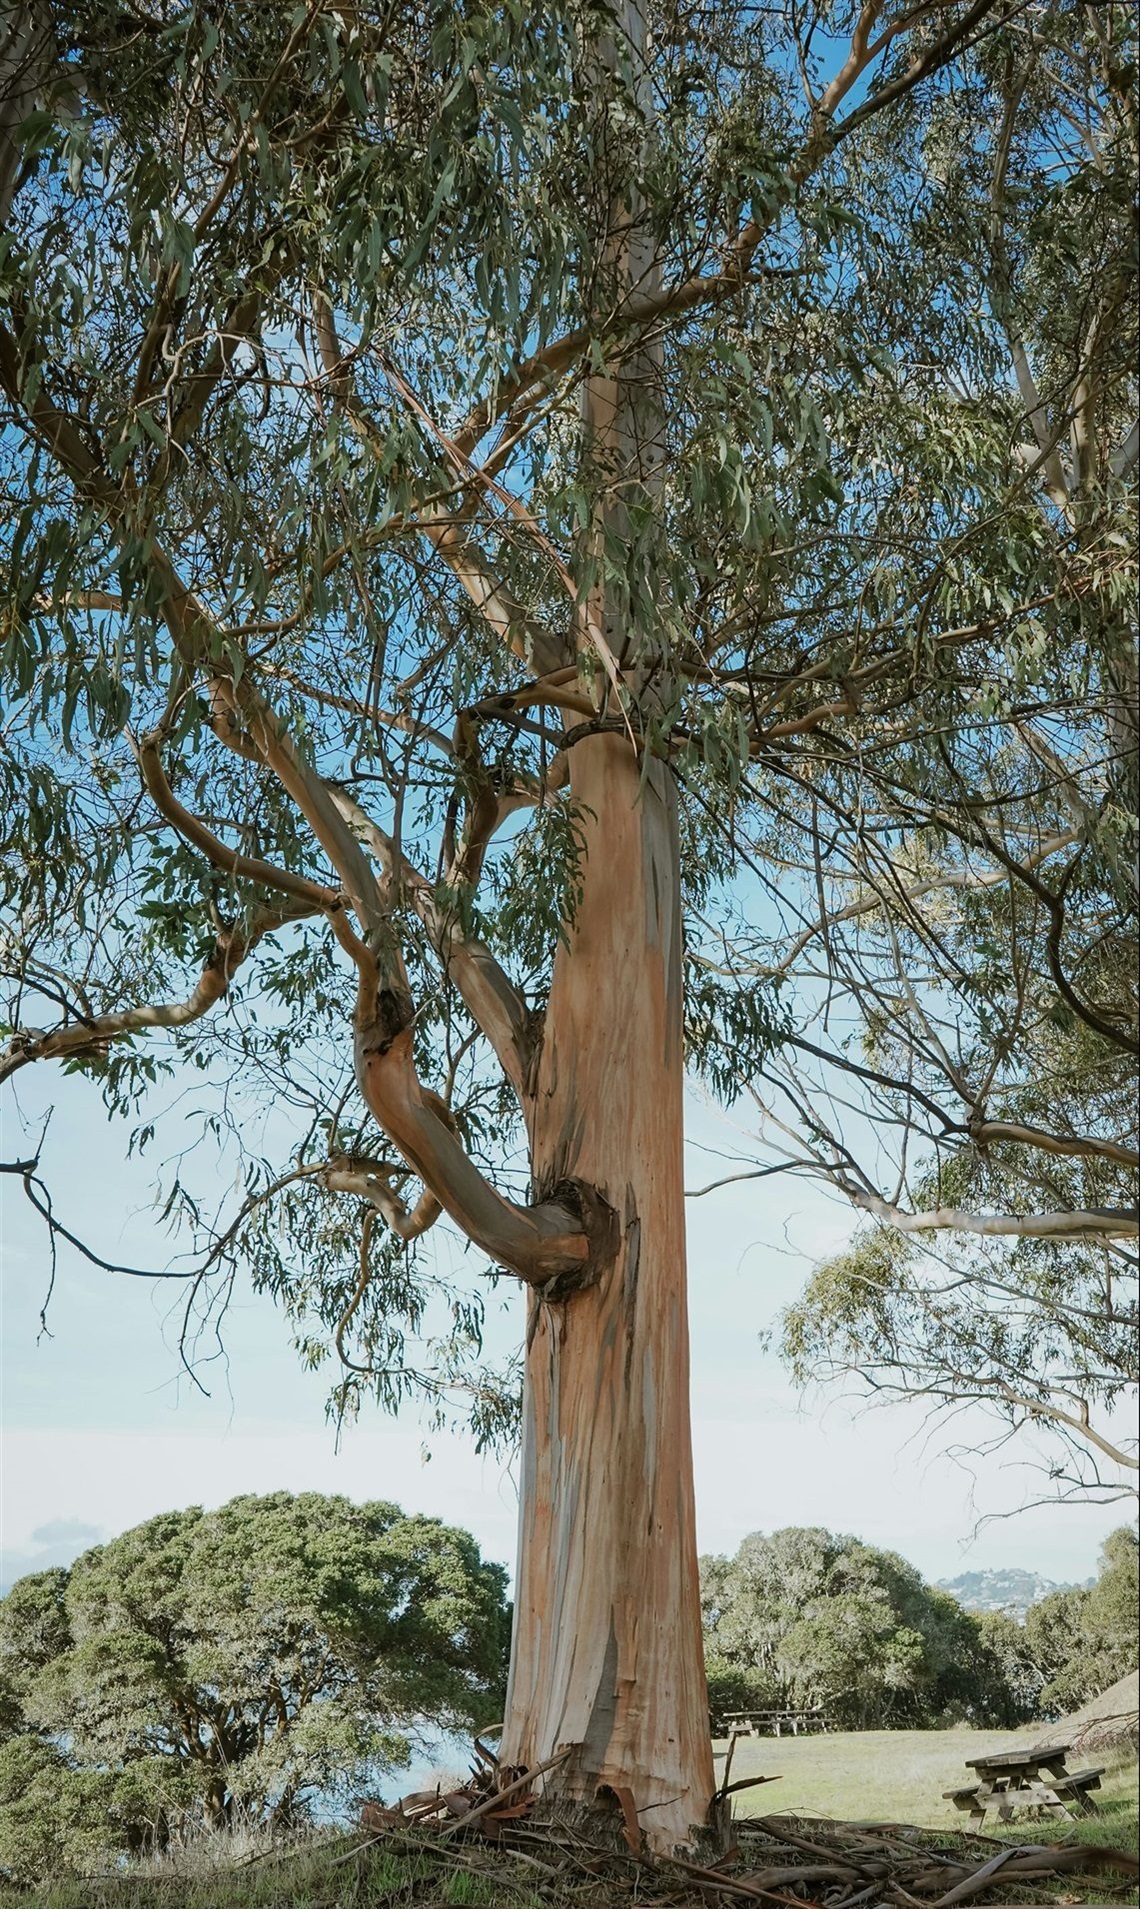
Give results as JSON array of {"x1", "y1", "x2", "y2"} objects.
[{"x1": 502, "y1": 733, "x2": 714, "y2": 1850}]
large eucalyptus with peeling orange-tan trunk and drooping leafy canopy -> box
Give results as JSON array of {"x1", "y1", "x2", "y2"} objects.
[{"x1": 0, "y1": 0, "x2": 1134, "y2": 1846}]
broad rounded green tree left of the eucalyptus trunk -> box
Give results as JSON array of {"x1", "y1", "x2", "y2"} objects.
[{"x1": 0, "y1": 1493, "x2": 510, "y2": 1875}]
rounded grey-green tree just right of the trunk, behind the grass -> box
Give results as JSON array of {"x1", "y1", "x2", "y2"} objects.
[{"x1": 701, "y1": 1527, "x2": 1031, "y2": 1730}]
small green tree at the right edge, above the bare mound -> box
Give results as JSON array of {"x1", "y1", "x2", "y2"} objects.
[{"x1": 1025, "y1": 1525, "x2": 1140, "y2": 1716}]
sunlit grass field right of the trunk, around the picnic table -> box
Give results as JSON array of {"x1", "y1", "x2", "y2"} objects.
[{"x1": 714, "y1": 1730, "x2": 1136, "y2": 1848}]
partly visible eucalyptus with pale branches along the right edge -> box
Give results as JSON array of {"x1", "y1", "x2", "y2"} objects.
[{"x1": 675, "y1": 8, "x2": 1140, "y2": 1499}]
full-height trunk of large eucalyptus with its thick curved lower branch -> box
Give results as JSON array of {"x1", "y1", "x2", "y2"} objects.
[{"x1": 357, "y1": 0, "x2": 714, "y2": 1850}]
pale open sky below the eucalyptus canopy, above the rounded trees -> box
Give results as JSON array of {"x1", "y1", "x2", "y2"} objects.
[{"x1": 0, "y1": 1069, "x2": 1129, "y2": 1583}]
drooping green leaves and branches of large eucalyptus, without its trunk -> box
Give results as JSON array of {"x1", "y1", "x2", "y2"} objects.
[{"x1": 0, "y1": 0, "x2": 1136, "y2": 1489}]
